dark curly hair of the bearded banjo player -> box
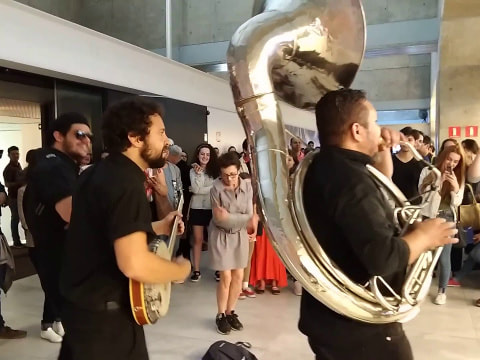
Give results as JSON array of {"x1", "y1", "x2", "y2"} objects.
[{"x1": 102, "y1": 97, "x2": 163, "y2": 153}]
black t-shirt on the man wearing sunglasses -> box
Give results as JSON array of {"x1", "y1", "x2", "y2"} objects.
[{"x1": 24, "y1": 149, "x2": 78, "y2": 251}]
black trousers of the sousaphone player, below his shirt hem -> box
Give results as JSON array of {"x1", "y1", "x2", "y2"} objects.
[{"x1": 308, "y1": 324, "x2": 413, "y2": 360}]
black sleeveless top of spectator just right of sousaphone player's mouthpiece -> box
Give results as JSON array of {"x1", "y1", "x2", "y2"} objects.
[{"x1": 392, "y1": 155, "x2": 426, "y2": 204}]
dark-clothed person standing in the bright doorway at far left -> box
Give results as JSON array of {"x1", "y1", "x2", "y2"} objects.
[{"x1": 3, "y1": 146, "x2": 23, "y2": 247}]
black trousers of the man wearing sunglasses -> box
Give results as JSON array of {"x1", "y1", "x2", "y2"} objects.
[{"x1": 34, "y1": 248, "x2": 62, "y2": 330}]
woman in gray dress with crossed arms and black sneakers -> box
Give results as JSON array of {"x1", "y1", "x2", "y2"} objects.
[{"x1": 208, "y1": 152, "x2": 255, "y2": 335}]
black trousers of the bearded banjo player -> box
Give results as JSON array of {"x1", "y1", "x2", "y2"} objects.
[{"x1": 58, "y1": 304, "x2": 148, "y2": 360}]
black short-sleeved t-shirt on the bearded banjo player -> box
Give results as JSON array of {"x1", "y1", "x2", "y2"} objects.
[{"x1": 60, "y1": 153, "x2": 154, "y2": 310}]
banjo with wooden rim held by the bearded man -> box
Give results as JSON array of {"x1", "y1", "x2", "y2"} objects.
[{"x1": 129, "y1": 180, "x2": 183, "y2": 325}]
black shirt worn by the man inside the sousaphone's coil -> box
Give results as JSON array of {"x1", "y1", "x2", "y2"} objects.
[{"x1": 299, "y1": 147, "x2": 409, "y2": 344}]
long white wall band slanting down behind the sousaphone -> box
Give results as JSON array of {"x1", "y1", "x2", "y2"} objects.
[{"x1": 0, "y1": 0, "x2": 315, "y2": 146}]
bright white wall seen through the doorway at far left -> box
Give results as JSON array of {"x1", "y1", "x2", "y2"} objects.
[{"x1": 0, "y1": 116, "x2": 42, "y2": 243}]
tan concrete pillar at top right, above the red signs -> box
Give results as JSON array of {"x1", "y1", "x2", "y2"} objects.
[{"x1": 438, "y1": 0, "x2": 480, "y2": 141}]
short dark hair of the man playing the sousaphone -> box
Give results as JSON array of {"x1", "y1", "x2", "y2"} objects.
[{"x1": 315, "y1": 89, "x2": 367, "y2": 145}]
